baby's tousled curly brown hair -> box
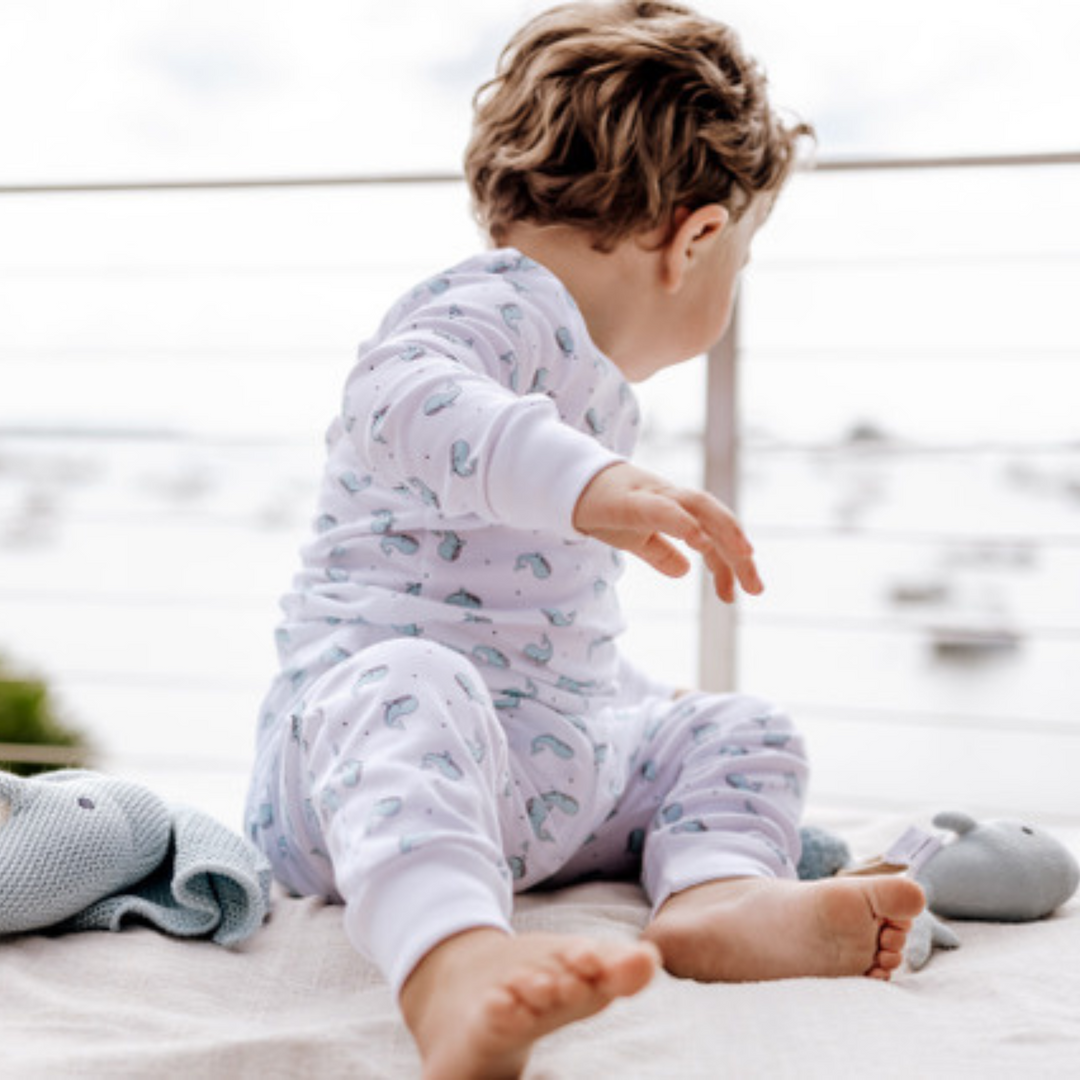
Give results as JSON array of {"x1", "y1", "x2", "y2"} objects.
[{"x1": 465, "y1": 0, "x2": 813, "y2": 251}]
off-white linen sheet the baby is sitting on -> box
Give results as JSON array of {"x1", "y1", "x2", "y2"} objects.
[{"x1": 0, "y1": 813, "x2": 1080, "y2": 1080}]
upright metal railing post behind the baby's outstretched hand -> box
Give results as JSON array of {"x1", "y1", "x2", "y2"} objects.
[{"x1": 698, "y1": 297, "x2": 739, "y2": 691}]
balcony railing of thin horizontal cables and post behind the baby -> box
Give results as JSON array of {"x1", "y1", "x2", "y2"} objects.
[{"x1": 0, "y1": 151, "x2": 1080, "y2": 812}]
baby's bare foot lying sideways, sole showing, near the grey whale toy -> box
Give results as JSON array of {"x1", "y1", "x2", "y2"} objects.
[{"x1": 645, "y1": 876, "x2": 926, "y2": 982}]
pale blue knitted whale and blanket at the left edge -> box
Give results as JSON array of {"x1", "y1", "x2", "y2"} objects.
[{"x1": 0, "y1": 769, "x2": 270, "y2": 945}]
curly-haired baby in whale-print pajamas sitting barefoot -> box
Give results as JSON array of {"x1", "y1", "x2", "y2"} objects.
[{"x1": 247, "y1": 0, "x2": 923, "y2": 1080}]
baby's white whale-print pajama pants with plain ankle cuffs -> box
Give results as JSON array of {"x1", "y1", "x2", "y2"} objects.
[{"x1": 248, "y1": 638, "x2": 807, "y2": 991}]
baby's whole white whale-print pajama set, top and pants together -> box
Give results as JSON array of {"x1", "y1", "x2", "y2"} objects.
[{"x1": 246, "y1": 248, "x2": 807, "y2": 990}]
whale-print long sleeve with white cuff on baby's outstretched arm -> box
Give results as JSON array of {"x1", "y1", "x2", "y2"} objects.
[{"x1": 343, "y1": 291, "x2": 621, "y2": 538}]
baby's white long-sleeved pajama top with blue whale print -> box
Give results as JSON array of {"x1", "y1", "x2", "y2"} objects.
[{"x1": 257, "y1": 248, "x2": 666, "y2": 727}]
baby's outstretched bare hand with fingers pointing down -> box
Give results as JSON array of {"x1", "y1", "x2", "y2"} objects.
[{"x1": 573, "y1": 461, "x2": 765, "y2": 604}]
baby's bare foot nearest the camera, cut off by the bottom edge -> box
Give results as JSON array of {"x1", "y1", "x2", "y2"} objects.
[{"x1": 401, "y1": 930, "x2": 659, "y2": 1080}]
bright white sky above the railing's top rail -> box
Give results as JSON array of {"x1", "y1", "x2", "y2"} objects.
[{"x1": 0, "y1": 0, "x2": 1080, "y2": 183}]
